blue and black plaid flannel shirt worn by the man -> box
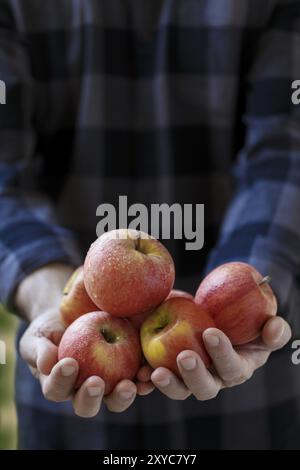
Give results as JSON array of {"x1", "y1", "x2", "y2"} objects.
[{"x1": 0, "y1": 0, "x2": 300, "y2": 448}]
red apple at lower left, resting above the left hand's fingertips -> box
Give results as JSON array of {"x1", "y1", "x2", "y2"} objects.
[{"x1": 58, "y1": 312, "x2": 142, "y2": 395}]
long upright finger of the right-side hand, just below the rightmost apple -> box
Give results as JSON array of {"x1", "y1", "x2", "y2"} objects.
[{"x1": 203, "y1": 328, "x2": 253, "y2": 387}]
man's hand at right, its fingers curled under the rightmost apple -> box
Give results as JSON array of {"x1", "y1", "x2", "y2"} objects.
[{"x1": 151, "y1": 317, "x2": 291, "y2": 401}]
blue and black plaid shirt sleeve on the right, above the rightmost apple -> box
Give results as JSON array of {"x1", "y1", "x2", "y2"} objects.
[{"x1": 208, "y1": 1, "x2": 300, "y2": 333}]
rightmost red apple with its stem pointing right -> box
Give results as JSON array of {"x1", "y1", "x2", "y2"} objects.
[{"x1": 195, "y1": 262, "x2": 277, "y2": 345}]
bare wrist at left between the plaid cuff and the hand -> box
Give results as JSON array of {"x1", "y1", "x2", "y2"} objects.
[{"x1": 15, "y1": 263, "x2": 75, "y2": 321}]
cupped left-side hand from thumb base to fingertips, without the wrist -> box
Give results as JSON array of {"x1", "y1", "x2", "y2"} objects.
[{"x1": 20, "y1": 309, "x2": 154, "y2": 418}]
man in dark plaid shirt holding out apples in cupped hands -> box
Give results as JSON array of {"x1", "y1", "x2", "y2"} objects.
[{"x1": 0, "y1": 0, "x2": 300, "y2": 449}]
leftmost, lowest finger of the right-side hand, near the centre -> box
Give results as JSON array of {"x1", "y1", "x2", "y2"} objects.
[{"x1": 151, "y1": 367, "x2": 191, "y2": 400}]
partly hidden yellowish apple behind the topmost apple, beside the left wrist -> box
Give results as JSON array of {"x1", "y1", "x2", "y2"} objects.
[{"x1": 60, "y1": 266, "x2": 98, "y2": 325}]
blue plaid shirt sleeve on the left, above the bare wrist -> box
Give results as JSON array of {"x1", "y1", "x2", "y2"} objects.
[{"x1": 0, "y1": 7, "x2": 80, "y2": 307}]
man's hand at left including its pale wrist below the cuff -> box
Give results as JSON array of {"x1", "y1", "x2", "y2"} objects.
[{"x1": 16, "y1": 264, "x2": 154, "y2": 417}]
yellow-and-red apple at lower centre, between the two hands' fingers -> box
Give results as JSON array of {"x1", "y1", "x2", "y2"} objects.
[{"x1": 140, "y1": 297, "x2": 215, "y2": 377}]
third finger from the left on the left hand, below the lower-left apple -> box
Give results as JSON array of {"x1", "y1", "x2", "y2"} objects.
[{"x1": 104, "y1": 380, "x2": 137, "y2": 413}]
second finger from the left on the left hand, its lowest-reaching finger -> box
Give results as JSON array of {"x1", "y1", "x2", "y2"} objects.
[{"x1": 73, "y1": 376, "x2": 105, "y2": 418}]
